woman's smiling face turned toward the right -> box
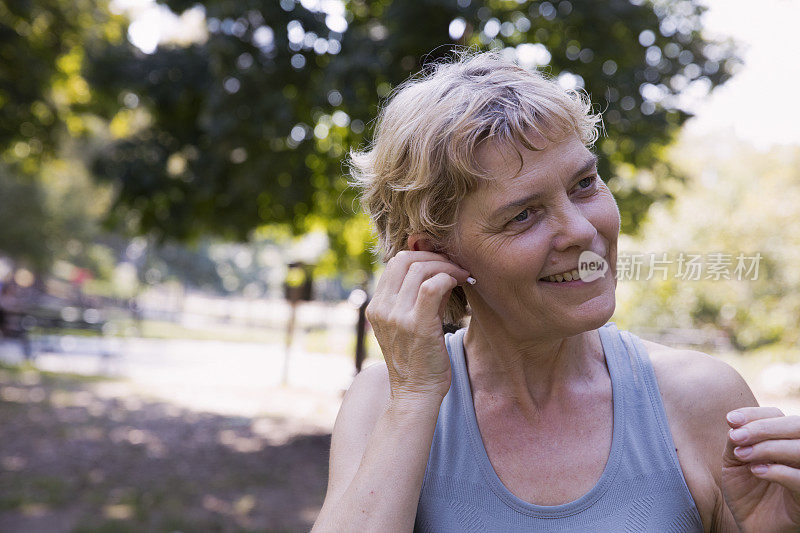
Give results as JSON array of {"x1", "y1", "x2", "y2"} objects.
[{"x1": 449, "y1": 131, "x2": 620, "y2": 336}]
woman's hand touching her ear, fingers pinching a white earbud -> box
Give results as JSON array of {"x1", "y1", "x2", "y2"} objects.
[{"x1": 367, "y1": 251, "x2": 469, "y2": 404}]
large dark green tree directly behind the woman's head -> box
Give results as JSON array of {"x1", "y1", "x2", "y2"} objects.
[{"x1": 86, "y1": 0, "x2": 736, "y2": 265}]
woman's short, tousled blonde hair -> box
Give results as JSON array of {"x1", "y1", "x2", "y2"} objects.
[{"x1": 350, "y1": 50, "x2": 600, "y2": 324}]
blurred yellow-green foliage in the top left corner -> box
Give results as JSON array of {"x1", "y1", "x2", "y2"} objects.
[{"x1": 0, "y1": 0, "x2": 123, "y2": 169}]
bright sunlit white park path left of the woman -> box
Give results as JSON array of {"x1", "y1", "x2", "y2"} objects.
[{"x1": 0, "y1": 337, "x2": 355, "y2": 431}]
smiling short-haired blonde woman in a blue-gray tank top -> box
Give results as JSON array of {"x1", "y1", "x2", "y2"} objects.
[{"x1": 314, "y1": 53, "x2": 800, "y2": 532}]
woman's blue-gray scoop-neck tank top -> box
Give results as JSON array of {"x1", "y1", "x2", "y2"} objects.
[{"x1": 414, "y1": 322, "x2": 703, "y2": 533}]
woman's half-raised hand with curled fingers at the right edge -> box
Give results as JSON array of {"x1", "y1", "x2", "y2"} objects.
[{"x1": 722, "y1": 407, "x2": 800, "y2": 533}]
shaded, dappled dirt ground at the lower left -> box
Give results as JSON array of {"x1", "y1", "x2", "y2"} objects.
[{"x1": 0, "y1": 366, "x2": 330, "y2": 533}]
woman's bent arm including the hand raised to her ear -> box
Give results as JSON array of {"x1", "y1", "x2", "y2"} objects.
[{"x1": 314, "y1": 251, "x2": 469, "y2": 532}]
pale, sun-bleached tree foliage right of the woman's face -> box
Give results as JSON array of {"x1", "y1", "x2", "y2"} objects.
[{"x1": 618, "y1": 132, "x2": 800, "y2": 350}]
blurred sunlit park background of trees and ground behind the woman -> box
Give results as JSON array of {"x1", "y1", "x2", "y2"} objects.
[{"x1": 0, "y1": 0, "x2": 800, "y2": 532}]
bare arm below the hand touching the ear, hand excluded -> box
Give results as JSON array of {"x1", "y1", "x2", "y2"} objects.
[{"x1": 312, "y1": 364, "x2": 441, "y2": 532}]
